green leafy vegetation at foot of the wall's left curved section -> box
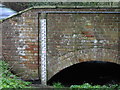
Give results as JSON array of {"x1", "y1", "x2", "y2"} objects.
[{"x1": 0, "y1": 60, "x2": 31, "y2": 89}]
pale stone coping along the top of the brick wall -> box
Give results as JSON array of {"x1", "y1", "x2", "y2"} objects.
[{"x1": 0, "y1": 6, "x2": 119, "y2": 23}]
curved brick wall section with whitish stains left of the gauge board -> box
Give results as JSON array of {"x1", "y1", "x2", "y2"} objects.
[{"x1": 3, "y1": 10, "x2": 38, "y2": 79}]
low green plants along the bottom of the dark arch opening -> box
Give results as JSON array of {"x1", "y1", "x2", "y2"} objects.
[{"x1": 53, "y1": 82, "x2": 120, "y2": 90}]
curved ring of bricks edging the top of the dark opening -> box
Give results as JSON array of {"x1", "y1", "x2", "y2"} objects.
[{"x1": 47, "y1": 48, "x2": 120, "y2": 80}]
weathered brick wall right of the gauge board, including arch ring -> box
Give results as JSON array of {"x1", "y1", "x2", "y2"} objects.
[{"x1": 47, "y1": 11, "x2": 120, "y2": 79}]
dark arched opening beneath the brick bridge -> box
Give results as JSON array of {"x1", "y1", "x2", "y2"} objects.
[{"x1": 48, "y1": 61, "x2": 120, "y2": 86}]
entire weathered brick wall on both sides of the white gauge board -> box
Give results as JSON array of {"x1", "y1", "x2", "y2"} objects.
[{"x1": 2, "y1": 8, "x2": 120, "y2": 79}]
